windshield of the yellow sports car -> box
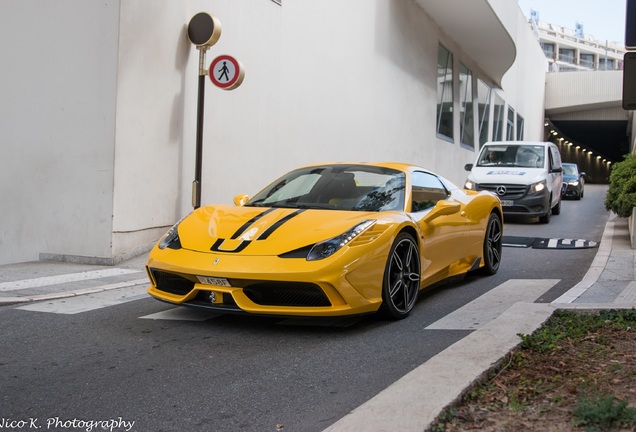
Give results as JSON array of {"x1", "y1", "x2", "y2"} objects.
[{"x1": 246, "y1": 164, "x2": 405, "y2": 212}]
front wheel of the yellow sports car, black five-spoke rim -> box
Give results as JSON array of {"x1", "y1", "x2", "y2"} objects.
[{"x1": 380, "y1": 232, "x2": 421, "y2": 320}]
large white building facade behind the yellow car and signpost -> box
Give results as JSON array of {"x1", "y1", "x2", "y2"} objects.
[{"x1": 0, "y1": 0, "x2": 548, "y2": 264}]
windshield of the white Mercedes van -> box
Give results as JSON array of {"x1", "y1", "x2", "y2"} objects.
[{"x1": 477, "y1": 144, "x2": 545, "y2": 168}]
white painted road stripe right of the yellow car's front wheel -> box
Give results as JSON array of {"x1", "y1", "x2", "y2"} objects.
[{"x1": 426, "y1": 279, "x2": 559, "y2": 330}]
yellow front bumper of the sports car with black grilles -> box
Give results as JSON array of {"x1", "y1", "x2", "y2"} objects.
[{"x1": 147, "y1": 249, "x2": 386, "y2": 317}]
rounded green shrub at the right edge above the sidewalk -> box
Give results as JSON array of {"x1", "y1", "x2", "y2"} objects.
[{"x1": 605, "y1": 154, "x2": 636, "y2": 217}]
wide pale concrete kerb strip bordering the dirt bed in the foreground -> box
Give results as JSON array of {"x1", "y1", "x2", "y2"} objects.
[{"x1": 325, "y1": 303, "x2": 554, "y2": 432}]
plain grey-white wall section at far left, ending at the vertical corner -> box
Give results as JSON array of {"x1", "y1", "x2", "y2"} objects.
[{"x1": 0, "y1": 0, "x2": 119, "y2": 263}]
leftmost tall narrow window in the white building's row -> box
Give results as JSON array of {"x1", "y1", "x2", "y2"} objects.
[{"x1": 437, "y1": 45, "x2": 453, "y2": 141}]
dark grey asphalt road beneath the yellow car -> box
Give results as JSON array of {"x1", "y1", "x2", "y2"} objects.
[{"x1": 0, "y1": 185, "x2": 608, "y2": 432}]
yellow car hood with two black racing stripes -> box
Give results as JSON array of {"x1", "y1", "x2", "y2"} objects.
[{"x1": 179, "y1": 205, "x2": 378, "y2": 255}]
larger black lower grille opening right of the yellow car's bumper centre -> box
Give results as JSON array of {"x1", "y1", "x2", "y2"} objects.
[{"x1": 243, "y1": 282, "x2": 331, "y2": 307}]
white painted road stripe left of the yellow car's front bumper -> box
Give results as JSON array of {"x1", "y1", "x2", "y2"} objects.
[{"x1": 16, "y1": 283, "x2": 150, "y2": 315}]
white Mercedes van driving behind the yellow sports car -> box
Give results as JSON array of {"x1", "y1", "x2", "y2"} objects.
[{"x1": 464, "y1": 141, "x2": 563, "y2": 223}]
